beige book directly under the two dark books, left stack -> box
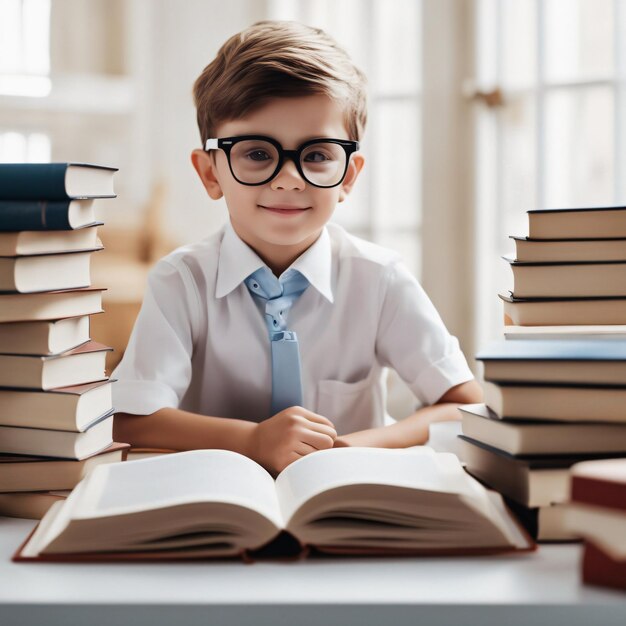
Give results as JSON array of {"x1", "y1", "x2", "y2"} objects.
[{"x1": 0, "y1": 222, "x2": 103, "y2": 256}]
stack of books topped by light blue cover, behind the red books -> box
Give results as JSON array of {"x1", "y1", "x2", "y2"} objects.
[{"x1": 461, "y1": 339, "x2": 626, "y2": 541}]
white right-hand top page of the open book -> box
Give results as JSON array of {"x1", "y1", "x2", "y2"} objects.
[{"x1": 276, "y1": 446, "x2": 472, "y2": 523}]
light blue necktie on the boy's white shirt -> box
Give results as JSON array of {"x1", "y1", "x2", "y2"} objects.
[{"x1": 245, "y1": 266, "x2": 309, "y2": 415}]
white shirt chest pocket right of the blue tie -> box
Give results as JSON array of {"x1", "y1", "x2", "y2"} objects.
[{"x1": 317, "y1": 367, "x2": 384, "y2": 435}]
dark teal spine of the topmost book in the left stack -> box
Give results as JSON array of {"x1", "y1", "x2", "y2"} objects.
[{"x1": 0, "y1": 163, "x2": 69, "y2": 200}]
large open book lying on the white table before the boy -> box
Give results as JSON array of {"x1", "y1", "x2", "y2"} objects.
[{"x1": 13, "y1": 447, "x2": 534, "y2": 561}]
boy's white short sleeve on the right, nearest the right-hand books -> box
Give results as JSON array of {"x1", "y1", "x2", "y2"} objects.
[{"x1": 376, "y1": 262, "x2": 474, "y2": 404}]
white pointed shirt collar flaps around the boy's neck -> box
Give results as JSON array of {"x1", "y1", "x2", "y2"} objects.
[{"x1": 215, "y1": 221, "x2": 333, "y2": 303}]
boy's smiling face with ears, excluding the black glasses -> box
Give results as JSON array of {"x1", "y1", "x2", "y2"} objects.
[{"x1": 192, "y1": 95, "x2": 364, "y2": 269}]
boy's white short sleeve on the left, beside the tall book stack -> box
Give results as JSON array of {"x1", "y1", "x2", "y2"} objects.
[{"x1": 111, "y1": 260, "x2": 196, "y2": 415}]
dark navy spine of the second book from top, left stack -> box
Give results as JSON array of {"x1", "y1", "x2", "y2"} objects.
[{"x1": 0, "y1": 200, "x2": 72, "y2": 231}]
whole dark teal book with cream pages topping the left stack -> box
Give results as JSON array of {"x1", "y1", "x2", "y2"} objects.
[{"x1": 0, "y1": 163, "x2": 118, "y2": 200}]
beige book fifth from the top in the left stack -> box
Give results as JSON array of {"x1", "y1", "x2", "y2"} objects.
[{"x1": 0, "y1": 287, "x2": 104, "y2": 322}]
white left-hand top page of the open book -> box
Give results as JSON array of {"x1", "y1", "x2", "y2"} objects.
[{"x1": 75, "y1": 450, "x2": 282, "y2": 527}]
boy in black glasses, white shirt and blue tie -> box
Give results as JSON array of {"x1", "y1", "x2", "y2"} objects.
[{"x1": 113, "y1": 21, "x2": 481, "y2": 475}]
